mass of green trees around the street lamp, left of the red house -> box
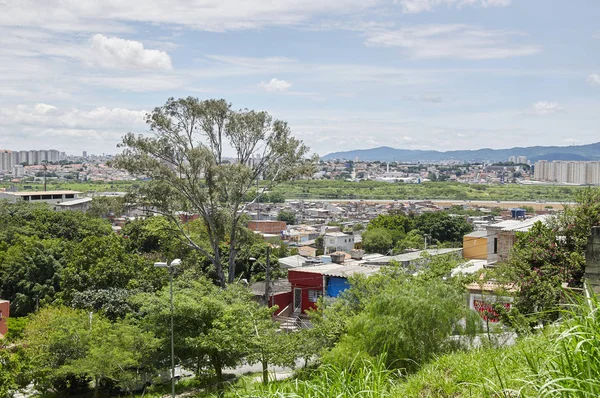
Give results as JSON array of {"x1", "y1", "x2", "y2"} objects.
[{"x1": 0, "y1": 201, "x2": 296, "y2": 396}]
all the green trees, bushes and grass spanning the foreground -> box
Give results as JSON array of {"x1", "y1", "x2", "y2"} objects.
[{"x1": 0, "y1": 189, "x2": 600, "y2": 397}]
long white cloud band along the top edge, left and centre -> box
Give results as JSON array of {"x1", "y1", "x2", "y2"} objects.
[{"x1": 0, "y1": 0, "x2": 378, "y2": 32}]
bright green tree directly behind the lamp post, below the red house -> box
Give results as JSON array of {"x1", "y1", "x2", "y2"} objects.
[{"x1": 132, "y1": 276, "x2": 271, "y2": 381}]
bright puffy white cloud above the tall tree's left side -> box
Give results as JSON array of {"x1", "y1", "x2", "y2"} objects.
[{"x1": 89, "y1": 34, "x2": 173, "y2": 70}]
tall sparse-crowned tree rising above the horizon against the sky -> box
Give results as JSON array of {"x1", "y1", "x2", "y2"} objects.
[{"x1": 115, "y1": 97, "x2": 312, "y2": 286}]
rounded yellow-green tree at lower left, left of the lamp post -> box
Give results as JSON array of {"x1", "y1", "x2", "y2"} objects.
[{"x1": 24, "y1": 307, "x2": 156, "y2": 393}]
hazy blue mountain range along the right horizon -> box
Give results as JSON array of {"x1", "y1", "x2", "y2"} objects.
[{"x1": 321, "y1": 142, "x2": 600, "y2": 162}]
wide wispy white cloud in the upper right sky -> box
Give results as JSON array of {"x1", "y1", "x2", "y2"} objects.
[{"x1": 365, "y1": 24, "x2": 541, "y2": 60}]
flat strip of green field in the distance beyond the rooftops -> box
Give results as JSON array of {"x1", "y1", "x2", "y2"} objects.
[{"x1": 0, "y1": 180, "x2": 584, "y2": 202}]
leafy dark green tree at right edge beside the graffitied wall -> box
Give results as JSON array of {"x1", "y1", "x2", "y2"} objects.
[{"x1": 497, "y1": 188, "x2": 600, "y2": 326}]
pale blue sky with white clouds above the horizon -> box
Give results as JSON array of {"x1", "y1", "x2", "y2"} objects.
[{"x1": 0, "y1": 0, "x2": 600, "y2": 155}]
